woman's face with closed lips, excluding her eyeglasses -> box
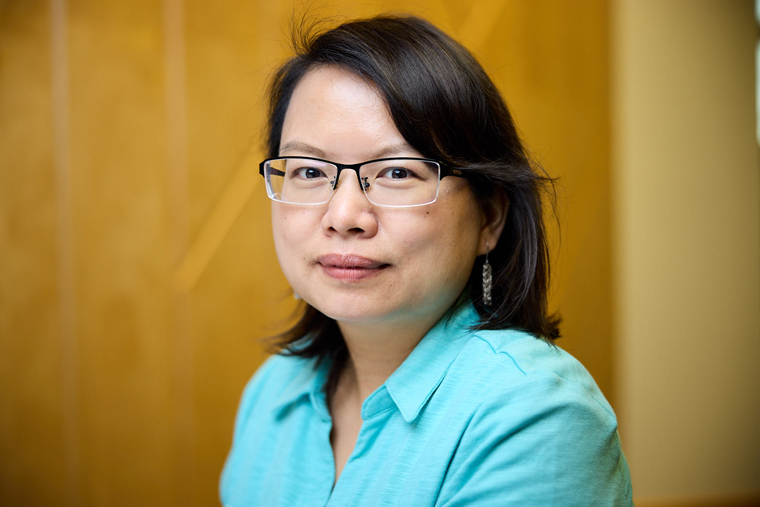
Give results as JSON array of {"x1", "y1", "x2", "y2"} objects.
[{"x1": 272, "y1": 66, "x2": 498, "y2": 325}]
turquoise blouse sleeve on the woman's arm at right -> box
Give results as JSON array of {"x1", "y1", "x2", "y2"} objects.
[{"x1": 436, "y1": 375, "x2": 633, "y2": 507}]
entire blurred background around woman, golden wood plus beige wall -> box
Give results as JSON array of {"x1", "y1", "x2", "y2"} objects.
[{"x1": 0, "y1": 0, "x2": 760, "y2": 507}]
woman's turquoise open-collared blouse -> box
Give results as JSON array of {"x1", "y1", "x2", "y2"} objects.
[{"x1": 220, "y1": 307, "x2": 633, "y2": 507}]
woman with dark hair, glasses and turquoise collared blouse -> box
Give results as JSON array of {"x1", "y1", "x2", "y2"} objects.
[{"x1": 221, "y1": 13, "x2": 631, "y2": 507}]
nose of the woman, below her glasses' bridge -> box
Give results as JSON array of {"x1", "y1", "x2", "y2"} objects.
[{"x1": 322, "y1": 170, "x2": 378, "y2": 238}]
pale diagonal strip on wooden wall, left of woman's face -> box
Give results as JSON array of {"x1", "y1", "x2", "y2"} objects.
[{"x1": 174, "y1": 146, "x2": 258, "y2": 291}]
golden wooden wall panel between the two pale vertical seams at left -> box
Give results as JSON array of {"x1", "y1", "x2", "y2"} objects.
[{"x1": 67, "y1": 0, "x2": 174, "y2": 505}]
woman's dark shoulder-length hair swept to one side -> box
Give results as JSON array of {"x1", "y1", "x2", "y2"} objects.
[{"x1": 266, "y1": 15, "x2": 560, "y2": 388}]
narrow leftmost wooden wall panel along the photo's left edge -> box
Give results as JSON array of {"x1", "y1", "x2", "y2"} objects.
[{"x1": 0, "y1": 1, "x2": 67, "y2": 506}]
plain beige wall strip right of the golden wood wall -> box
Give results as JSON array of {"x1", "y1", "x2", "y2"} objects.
[{"x1": 612, "y1": 0, "x2": 760, "y2": 505}]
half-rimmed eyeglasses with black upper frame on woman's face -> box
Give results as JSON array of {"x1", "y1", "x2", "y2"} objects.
[{"x1": 259, "y1": 157, "x2": 466, "y2": 208}]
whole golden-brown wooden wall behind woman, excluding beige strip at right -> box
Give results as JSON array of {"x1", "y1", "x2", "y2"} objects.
[{"x1": 0, "y1": 0, "x2": 612, "y2": 506}]
